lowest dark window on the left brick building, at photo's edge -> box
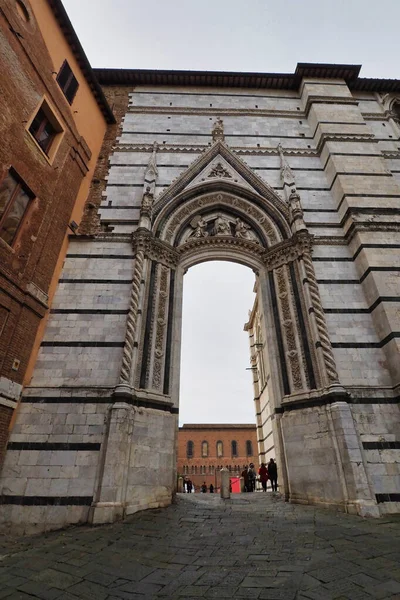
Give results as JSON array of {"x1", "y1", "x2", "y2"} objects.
[{"x1": 0, "y1": 169, "x2": 34, "y2": 246}]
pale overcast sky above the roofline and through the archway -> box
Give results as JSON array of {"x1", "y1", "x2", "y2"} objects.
[{"x1": 61, "y1": 0, "x2": 400, "y2": 423}]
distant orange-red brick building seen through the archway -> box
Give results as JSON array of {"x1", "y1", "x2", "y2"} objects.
[{"x1": 177, "y1": 424, "x2": 258, "y2": 487}]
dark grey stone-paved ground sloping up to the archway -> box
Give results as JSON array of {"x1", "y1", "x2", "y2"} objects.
[{"x1": 0, "y1": 493, "x2": 400, "y2": 600}]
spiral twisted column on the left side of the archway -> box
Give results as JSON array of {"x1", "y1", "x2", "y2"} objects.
[{"x1": 119, "y1": 250, "x2": 144, "y2": 385}]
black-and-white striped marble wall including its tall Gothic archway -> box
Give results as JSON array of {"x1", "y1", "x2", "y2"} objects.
[{"x1": 1, "y1": 51, "x2": 400, "y2": 531}]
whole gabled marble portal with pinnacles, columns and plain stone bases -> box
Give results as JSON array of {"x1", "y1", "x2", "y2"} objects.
[{"x1": 0, "y1": 140, "x2": 379, "y2": 524}]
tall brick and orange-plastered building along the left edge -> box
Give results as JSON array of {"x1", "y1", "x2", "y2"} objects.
[{"x1": 0, "y1": 0, "x2": 114, "y2": 464}]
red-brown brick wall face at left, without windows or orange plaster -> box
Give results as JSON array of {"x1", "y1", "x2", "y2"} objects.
[{"x1": 0, "y1": 0, "x2": 108, "y2": 466}]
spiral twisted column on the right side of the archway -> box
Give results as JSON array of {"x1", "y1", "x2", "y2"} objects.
[{"x1": 303, "y1": 252, "x2": 339, "y2": 383}]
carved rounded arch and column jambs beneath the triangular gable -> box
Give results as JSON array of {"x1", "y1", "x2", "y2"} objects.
[{"x1": 120, "y1": 178, "x2": 338, "y2": 420}]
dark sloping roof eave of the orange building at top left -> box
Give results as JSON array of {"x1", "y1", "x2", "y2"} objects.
[{"x1": 47, "y1": 0, "x2": 116, "y2": 124}]
